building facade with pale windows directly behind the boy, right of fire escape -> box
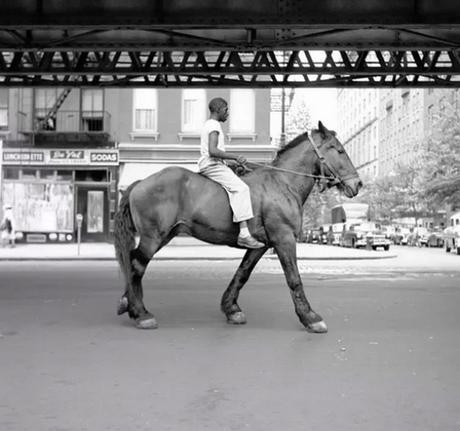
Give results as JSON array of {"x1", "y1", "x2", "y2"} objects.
[{"x1": 115, "y1": 88, "x2": 274, "y2": 189}]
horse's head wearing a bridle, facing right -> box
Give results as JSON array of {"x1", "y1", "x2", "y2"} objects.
[{"x1": 311, "y1": 121, "x2": 363, "y2": 198}]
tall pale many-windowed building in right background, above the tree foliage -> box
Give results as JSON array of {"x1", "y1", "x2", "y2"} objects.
[{"x1": 337, "y1": 88, "x2": 460, "y2": 177}]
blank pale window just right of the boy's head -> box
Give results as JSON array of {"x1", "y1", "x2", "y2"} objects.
[{"x1": 230, "y1": 89, "x2": 255, "y2": 134}]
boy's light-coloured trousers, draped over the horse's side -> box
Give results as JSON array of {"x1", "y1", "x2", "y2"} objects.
[{"x1": 200, "y1": 163, "x2": 254, "y2": 223}]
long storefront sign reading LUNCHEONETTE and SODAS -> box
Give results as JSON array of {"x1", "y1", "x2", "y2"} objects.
[{"x1": 2, "y1": 149, "x2": 119, "y2": 166}]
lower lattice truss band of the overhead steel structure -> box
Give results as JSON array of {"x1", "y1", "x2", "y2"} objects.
[{"x1": 0, "y1": 50, "x2": 460, "y2": 87}]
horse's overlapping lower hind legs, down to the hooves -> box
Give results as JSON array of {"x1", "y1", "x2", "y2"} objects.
[{"x1": 118, "y1": 236, "x2": 161, "y2": 329}]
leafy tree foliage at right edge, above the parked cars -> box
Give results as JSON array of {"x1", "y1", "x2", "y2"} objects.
[{"x1": 360, "y1": 92, "x2": 460, "y2": 220}]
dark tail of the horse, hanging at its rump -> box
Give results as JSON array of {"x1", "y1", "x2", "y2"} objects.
[{"x1": 113, "y1": 181, "x2": 139, "y2": 282}]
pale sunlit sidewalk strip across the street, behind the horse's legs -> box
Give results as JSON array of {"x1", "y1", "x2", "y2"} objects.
[{"x1": 0, "y1": 237, "x2": 396, "y2": 261}]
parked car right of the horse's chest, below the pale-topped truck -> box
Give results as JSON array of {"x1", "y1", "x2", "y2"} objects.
[{"x1": 340, "y1": 222, "x2": 390, "y2": 250}]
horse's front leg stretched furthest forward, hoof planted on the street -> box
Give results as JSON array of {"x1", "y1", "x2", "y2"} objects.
[{"x1": 275, "y1": 235, "x2": 327, "y2": 333}]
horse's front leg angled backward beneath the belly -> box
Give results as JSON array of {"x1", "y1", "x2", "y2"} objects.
[{"x1": 220, "y1": 247, "x2": 267, "y2": 325}]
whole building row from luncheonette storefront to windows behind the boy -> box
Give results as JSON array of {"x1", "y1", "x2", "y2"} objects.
[{"x1": 0, "y1": 88, "x2": 274, "y2": 242}]
